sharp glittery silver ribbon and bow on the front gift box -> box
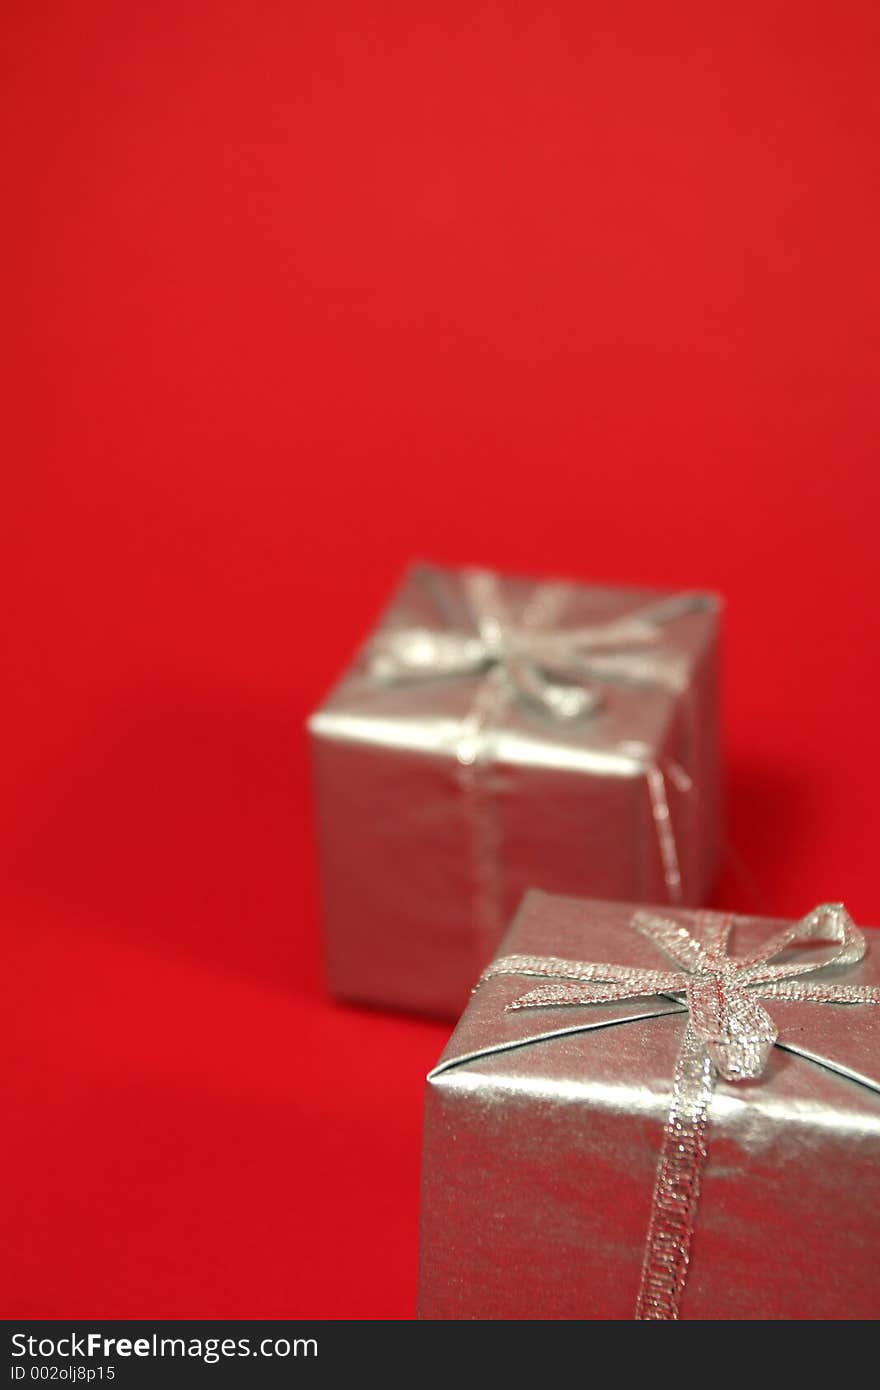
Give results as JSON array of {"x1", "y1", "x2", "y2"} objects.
[{"x1": 482, "y1": 904, "x2": 880, "y2": 1319}]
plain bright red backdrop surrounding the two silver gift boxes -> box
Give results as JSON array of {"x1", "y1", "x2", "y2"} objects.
[{"x1": 0, "y1": 0, "x2": 880, "y2": 1318}]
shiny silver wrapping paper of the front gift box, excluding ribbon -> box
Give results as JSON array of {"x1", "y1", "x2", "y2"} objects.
[{"x1": 418, "y1": 892, "x2": 880, "y2": 1319}]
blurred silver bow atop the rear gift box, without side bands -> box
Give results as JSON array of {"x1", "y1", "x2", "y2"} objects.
[{"x1": 370, "y1": 570, "x2": 705, "y2": 719}]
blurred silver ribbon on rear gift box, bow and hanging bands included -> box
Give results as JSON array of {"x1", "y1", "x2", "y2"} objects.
[{"x1": 368, "y1": 569, "x2": 706, "y2": 922}]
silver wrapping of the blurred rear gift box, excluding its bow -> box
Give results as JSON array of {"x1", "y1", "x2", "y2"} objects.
[{"x1": 309, "y1": 564, "x2": 720, "y2": 1017}]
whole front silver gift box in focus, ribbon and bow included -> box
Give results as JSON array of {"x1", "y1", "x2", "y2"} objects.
[{"x1": 418, "y1": 892, "x2": 880, "y2": 1319}]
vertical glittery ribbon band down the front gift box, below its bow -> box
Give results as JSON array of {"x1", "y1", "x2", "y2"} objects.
[{"x1": 635, "y1": 1023, "x2": 715, "y2": 1321}]
